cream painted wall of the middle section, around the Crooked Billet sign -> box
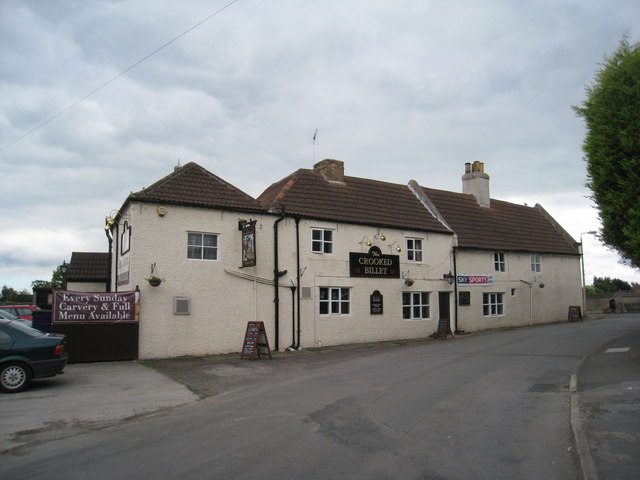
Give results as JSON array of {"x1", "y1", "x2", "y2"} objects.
[{"x1": 280, "y1": 219, "x2": 454, "y2": 347}]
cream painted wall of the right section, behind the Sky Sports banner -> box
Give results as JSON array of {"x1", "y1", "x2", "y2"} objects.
[{"x1": 456, "y1": 249, "x2": 582, "y2": 331}]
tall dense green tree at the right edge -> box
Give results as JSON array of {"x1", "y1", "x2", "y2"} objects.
[{"x1": 573, "y1": 35, "x2": 640, "y2": 267}]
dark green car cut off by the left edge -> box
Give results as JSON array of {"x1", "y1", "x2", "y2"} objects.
[{"x1": 0, "y1": 318, "x2": 69, "y2": 393}]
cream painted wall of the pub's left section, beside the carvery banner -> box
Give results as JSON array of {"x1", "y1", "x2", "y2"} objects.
[{"x1": 114, "y1": 203, "x2": 276, "y2": 358}]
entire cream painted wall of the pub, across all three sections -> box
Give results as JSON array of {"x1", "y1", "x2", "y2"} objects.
[{"x1": 112, "y1": 199, "x2": 581, "y2": 359}]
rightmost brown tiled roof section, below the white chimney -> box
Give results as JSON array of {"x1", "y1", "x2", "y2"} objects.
[{"x1": 422, "y1": 187, "x2": 578, "y2": 255}]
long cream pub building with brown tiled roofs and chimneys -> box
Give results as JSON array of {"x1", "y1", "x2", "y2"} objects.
[{"x1": 99, "y1": 159, "x2": 581, "y2": 358}]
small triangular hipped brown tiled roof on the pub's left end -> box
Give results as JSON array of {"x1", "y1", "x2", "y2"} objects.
[{"x1": 125, "y1": 162, "x2": 264, "y2": 211}]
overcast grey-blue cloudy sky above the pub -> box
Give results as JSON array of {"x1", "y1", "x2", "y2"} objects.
[{"x1": 0, "y1": 0, "x2": 640, "y2": 289}]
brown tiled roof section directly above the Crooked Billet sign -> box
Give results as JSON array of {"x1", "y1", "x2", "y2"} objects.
[{"x1": 258, "y1": 169, "x2": 452, "y2": 234}]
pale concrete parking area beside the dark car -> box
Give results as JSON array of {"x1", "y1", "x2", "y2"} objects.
[{"x1": 0, "y1": 361, "x2": 198, "y2": 454}]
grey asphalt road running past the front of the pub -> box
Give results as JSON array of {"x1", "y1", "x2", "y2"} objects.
[{"x1": 0, "y1": 317, "x2": 640, "y2": 480}]
